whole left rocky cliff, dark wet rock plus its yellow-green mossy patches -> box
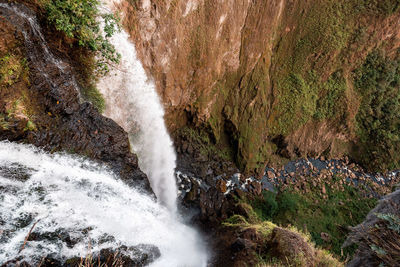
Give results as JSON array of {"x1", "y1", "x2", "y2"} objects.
[{"x1": 0, "y1": 1, "x2": 152, "y2": 192}]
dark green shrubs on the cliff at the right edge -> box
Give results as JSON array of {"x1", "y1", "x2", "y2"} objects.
[{"x1": 355, "y1": 51, "x2": 400, "y2": 170}]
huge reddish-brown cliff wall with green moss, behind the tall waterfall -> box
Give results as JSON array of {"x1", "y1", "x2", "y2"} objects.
[{"x1": 120, "y1": 0, "x2": 400, "y2": 175}]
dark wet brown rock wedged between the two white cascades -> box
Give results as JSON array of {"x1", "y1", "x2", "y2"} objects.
[{"x1": 0, "y1": 1, "x2": 151, "y2": 192}]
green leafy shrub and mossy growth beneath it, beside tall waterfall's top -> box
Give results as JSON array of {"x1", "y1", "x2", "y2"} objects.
[{"x1": 40, "y1": 0, "x2": 121, "y2": 112}]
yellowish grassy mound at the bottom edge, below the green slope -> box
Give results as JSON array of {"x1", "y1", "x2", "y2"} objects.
[{"x1": 223, "y1": 200, "x2": 343, "y2": 267}]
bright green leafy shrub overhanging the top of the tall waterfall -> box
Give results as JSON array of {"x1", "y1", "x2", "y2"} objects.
[{"x1": 45, "y1": 0, "x2": 120, "y2": 74}]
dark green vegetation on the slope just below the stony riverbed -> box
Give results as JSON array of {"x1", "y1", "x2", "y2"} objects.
[{"x1": 245, "y1": 178, "x2": 377, "y2": 256}]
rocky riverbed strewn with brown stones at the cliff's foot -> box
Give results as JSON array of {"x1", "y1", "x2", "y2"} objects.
[{"x1": 176, "y1": 158, "x2": 400, "y2": 205}]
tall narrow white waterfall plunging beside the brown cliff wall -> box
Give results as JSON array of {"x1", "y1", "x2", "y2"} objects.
[{"x1": 97, "y1": 0, "x2": 177, "y2": 213}]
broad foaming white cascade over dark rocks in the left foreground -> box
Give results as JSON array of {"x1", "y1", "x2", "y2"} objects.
[{"x1": 0, "y1": 142, "x2": 207, "y2": 267}]
